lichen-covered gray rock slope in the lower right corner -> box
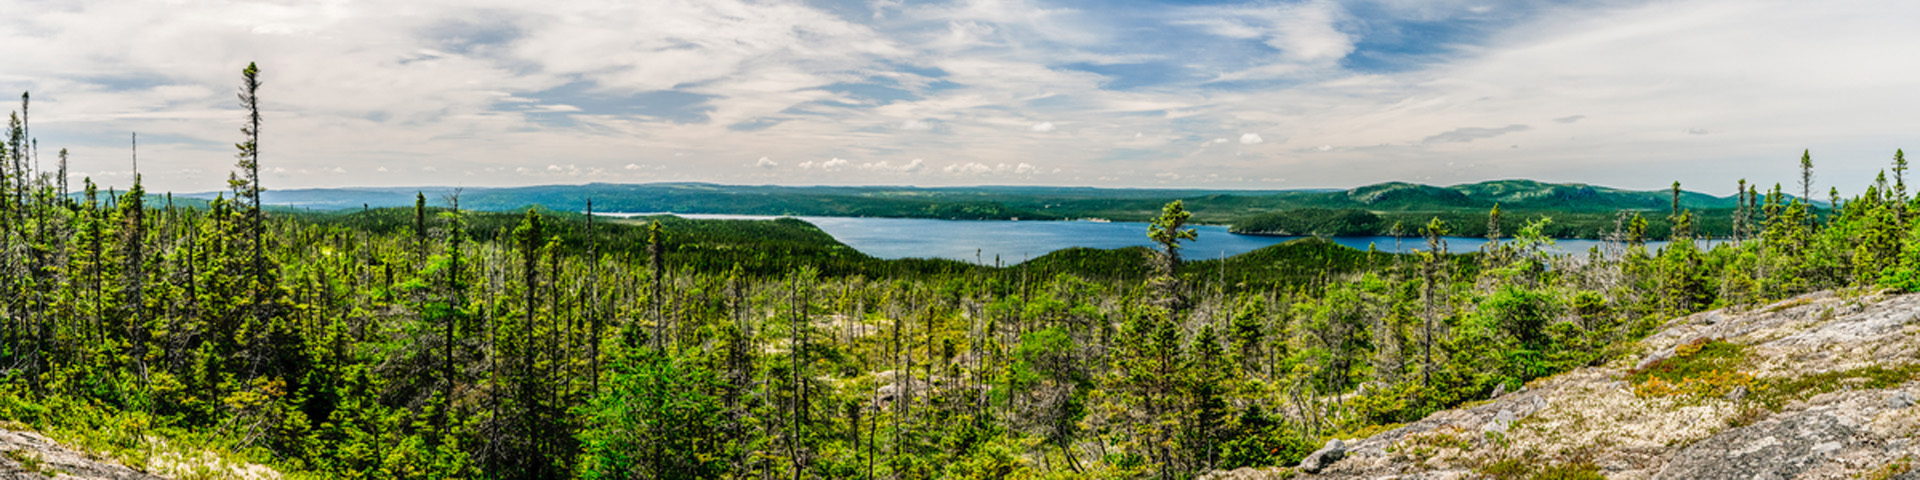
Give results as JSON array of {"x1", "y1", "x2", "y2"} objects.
[{"x1": 1210, "y1": 292, "x2": 1920, "y2": 480}]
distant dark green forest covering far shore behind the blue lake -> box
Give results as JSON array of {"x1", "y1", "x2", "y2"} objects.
[{"x1": 192, "y1": 174, "x2": 1745, "y2": 238}]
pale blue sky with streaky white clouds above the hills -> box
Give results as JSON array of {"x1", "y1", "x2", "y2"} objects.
[{"x1": 0, "y1": 0, "x2": 1920, "y2": 194}]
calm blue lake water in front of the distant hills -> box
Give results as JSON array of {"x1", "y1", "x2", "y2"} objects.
[{"x1": 595, "y1": 213, "x2": 1712, "y2": 263}]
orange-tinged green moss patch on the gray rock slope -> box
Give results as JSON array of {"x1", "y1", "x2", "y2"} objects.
[{"x1": 1628, "y1": 338, "x2": 1753, "y2": 397}]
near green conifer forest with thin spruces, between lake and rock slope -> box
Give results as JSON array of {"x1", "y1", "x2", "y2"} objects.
[{"x1": 0, "y1": 65, "x2": 1920, "y2": 478}]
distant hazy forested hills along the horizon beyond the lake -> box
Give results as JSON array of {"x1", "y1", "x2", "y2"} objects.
[{"x1": 176, "y1": 180, "x2": 1766, "y2": 225}]
